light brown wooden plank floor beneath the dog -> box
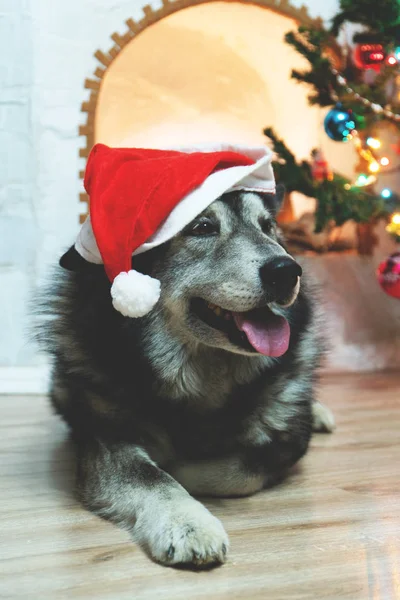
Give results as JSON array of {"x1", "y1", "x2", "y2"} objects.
[{"x1": 0, "y1": 375, "x2": 400, "y2": 600}]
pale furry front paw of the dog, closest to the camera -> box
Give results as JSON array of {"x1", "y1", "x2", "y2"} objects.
[{"x1": 135, "y1": 499, "x2": 229, "y2": 568}]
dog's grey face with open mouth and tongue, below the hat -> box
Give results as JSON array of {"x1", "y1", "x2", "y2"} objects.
[{"x1": 137, "y1": 189, "x2": 302, "y2": 357}]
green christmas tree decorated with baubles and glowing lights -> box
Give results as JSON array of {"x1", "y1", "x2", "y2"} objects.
[{"x1": 264, "y1": 0, "x2": 400, "y2": 254}]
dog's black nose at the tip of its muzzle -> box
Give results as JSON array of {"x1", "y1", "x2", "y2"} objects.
[{"x1": 260, "y1": 256, "x2": 303, "y2": 298}]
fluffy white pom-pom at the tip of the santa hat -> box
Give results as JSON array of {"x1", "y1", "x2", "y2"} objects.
[{"x1": 111, "y1": 271, "x2": 161, "y2": 318}]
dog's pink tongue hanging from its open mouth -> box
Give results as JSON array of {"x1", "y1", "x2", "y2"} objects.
[{"x1": 233, "y1": 313, "x2": 290, "y2": 358}]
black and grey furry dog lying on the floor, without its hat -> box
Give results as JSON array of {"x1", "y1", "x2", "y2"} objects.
[{"x1": 40, "y1": 186, "x2": 333, "y2": 568}]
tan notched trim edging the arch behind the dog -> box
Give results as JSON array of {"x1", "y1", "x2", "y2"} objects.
[{"x1": 79, "y1": 0, "x2": 322, "y2": 218}]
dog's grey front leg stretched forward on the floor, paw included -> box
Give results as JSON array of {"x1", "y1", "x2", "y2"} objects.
[{"x1": 78, "y1": 439, "x2": 228, "y2": 566}]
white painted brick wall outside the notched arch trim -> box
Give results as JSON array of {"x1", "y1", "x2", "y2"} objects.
[{"x1": 0, "y1": 0, "x2": 337, "y2": 366}]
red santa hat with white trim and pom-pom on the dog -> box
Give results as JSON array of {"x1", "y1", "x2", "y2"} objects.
[{"x1": 71, "y1": 144, "x2": 275, "y2": 317}]
